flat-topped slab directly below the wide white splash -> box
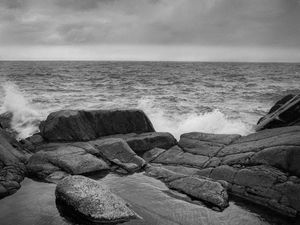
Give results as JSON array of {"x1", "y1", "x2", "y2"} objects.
[{"x1": 178, "y1": 132, "x2": 240, "y2": 157}]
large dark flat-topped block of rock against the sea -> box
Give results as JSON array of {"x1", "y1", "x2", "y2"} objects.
[{"x1": 40, "y1": 110, "x2": 154, "y2": 142}]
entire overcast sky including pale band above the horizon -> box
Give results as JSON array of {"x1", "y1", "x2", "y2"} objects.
[{"x1": 0, "y1": 0, "x2": 300, "y2": 62}]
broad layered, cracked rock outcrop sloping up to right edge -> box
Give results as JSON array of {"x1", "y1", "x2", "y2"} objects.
[{"x1": 147, "y1": 126, "x2": 300, "y2": 216}]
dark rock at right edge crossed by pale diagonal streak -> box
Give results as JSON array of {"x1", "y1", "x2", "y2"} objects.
[{"x1": 257, "y1": 95, "x2": 300, "y2": 129}]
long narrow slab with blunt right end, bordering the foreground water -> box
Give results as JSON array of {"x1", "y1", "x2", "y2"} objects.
[{"x1": 146, "y1": 166, "x2": 228, "y2": 209}]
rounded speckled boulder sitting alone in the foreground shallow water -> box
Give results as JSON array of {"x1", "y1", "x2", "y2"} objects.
[{"x1": 55, "y1": 176, "x2": 139, "y2": 224}]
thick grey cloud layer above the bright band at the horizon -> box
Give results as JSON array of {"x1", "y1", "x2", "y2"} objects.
[{"x1": 0, "y1": 0, "x2": 300, "y2": 60}]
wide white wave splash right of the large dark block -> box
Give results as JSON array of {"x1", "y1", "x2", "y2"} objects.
[{"x1": 139, "y1": 100, "x2": 252, "y2": 139}]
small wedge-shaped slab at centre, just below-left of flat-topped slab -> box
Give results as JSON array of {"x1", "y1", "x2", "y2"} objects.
[{"x1": 152, "y1": 146, "x2": 209, "y2": 168}]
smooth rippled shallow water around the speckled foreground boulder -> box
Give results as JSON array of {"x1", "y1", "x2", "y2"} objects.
[{"x1": 0, "y1": 174, "x2": 299, "y2": 225}]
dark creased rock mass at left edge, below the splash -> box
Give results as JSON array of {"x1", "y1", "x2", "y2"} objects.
[{"x1": 0, "y1": 128, "x2": 27, "y2": 198}]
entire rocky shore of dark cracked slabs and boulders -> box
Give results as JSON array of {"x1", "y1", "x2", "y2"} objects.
[{"x1": 0, "y1": 95, "x2": 300, "y2": 223}]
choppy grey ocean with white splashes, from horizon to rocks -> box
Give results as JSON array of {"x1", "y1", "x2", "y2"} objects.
[{"x1": 0, "y1": 61, "x2": 300, "y2": 138}]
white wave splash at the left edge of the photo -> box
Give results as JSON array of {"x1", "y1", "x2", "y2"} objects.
[{"x1": 2, "y1": 82, "x2": 39, "y2": 139}]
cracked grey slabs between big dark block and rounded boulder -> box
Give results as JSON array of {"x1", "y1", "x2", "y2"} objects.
[{"x1": 27, "y1": 138, "x2": 145, "y2": 179}]
